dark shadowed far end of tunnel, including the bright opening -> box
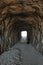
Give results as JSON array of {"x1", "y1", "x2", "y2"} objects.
[{"x1": 14, "y1": 21, "x2": 32, "y2": 44}]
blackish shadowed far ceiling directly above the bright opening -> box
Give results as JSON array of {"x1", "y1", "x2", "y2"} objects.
[{"x1": 13, "y1": 20, "x2": 32, "y2": 31}]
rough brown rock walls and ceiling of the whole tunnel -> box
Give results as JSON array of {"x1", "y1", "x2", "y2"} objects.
[{"x1": 0, "y1": 0, "x2": 43, "y2": 54}]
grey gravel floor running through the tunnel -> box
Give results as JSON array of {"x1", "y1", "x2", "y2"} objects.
[{"x1": 0, "y1": 43, "x2": 43, "y2": 65}]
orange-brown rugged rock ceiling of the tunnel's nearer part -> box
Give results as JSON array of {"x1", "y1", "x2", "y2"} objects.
[{"x1": 0, "y1": 0, "x2": 43, "y2": 34}]
